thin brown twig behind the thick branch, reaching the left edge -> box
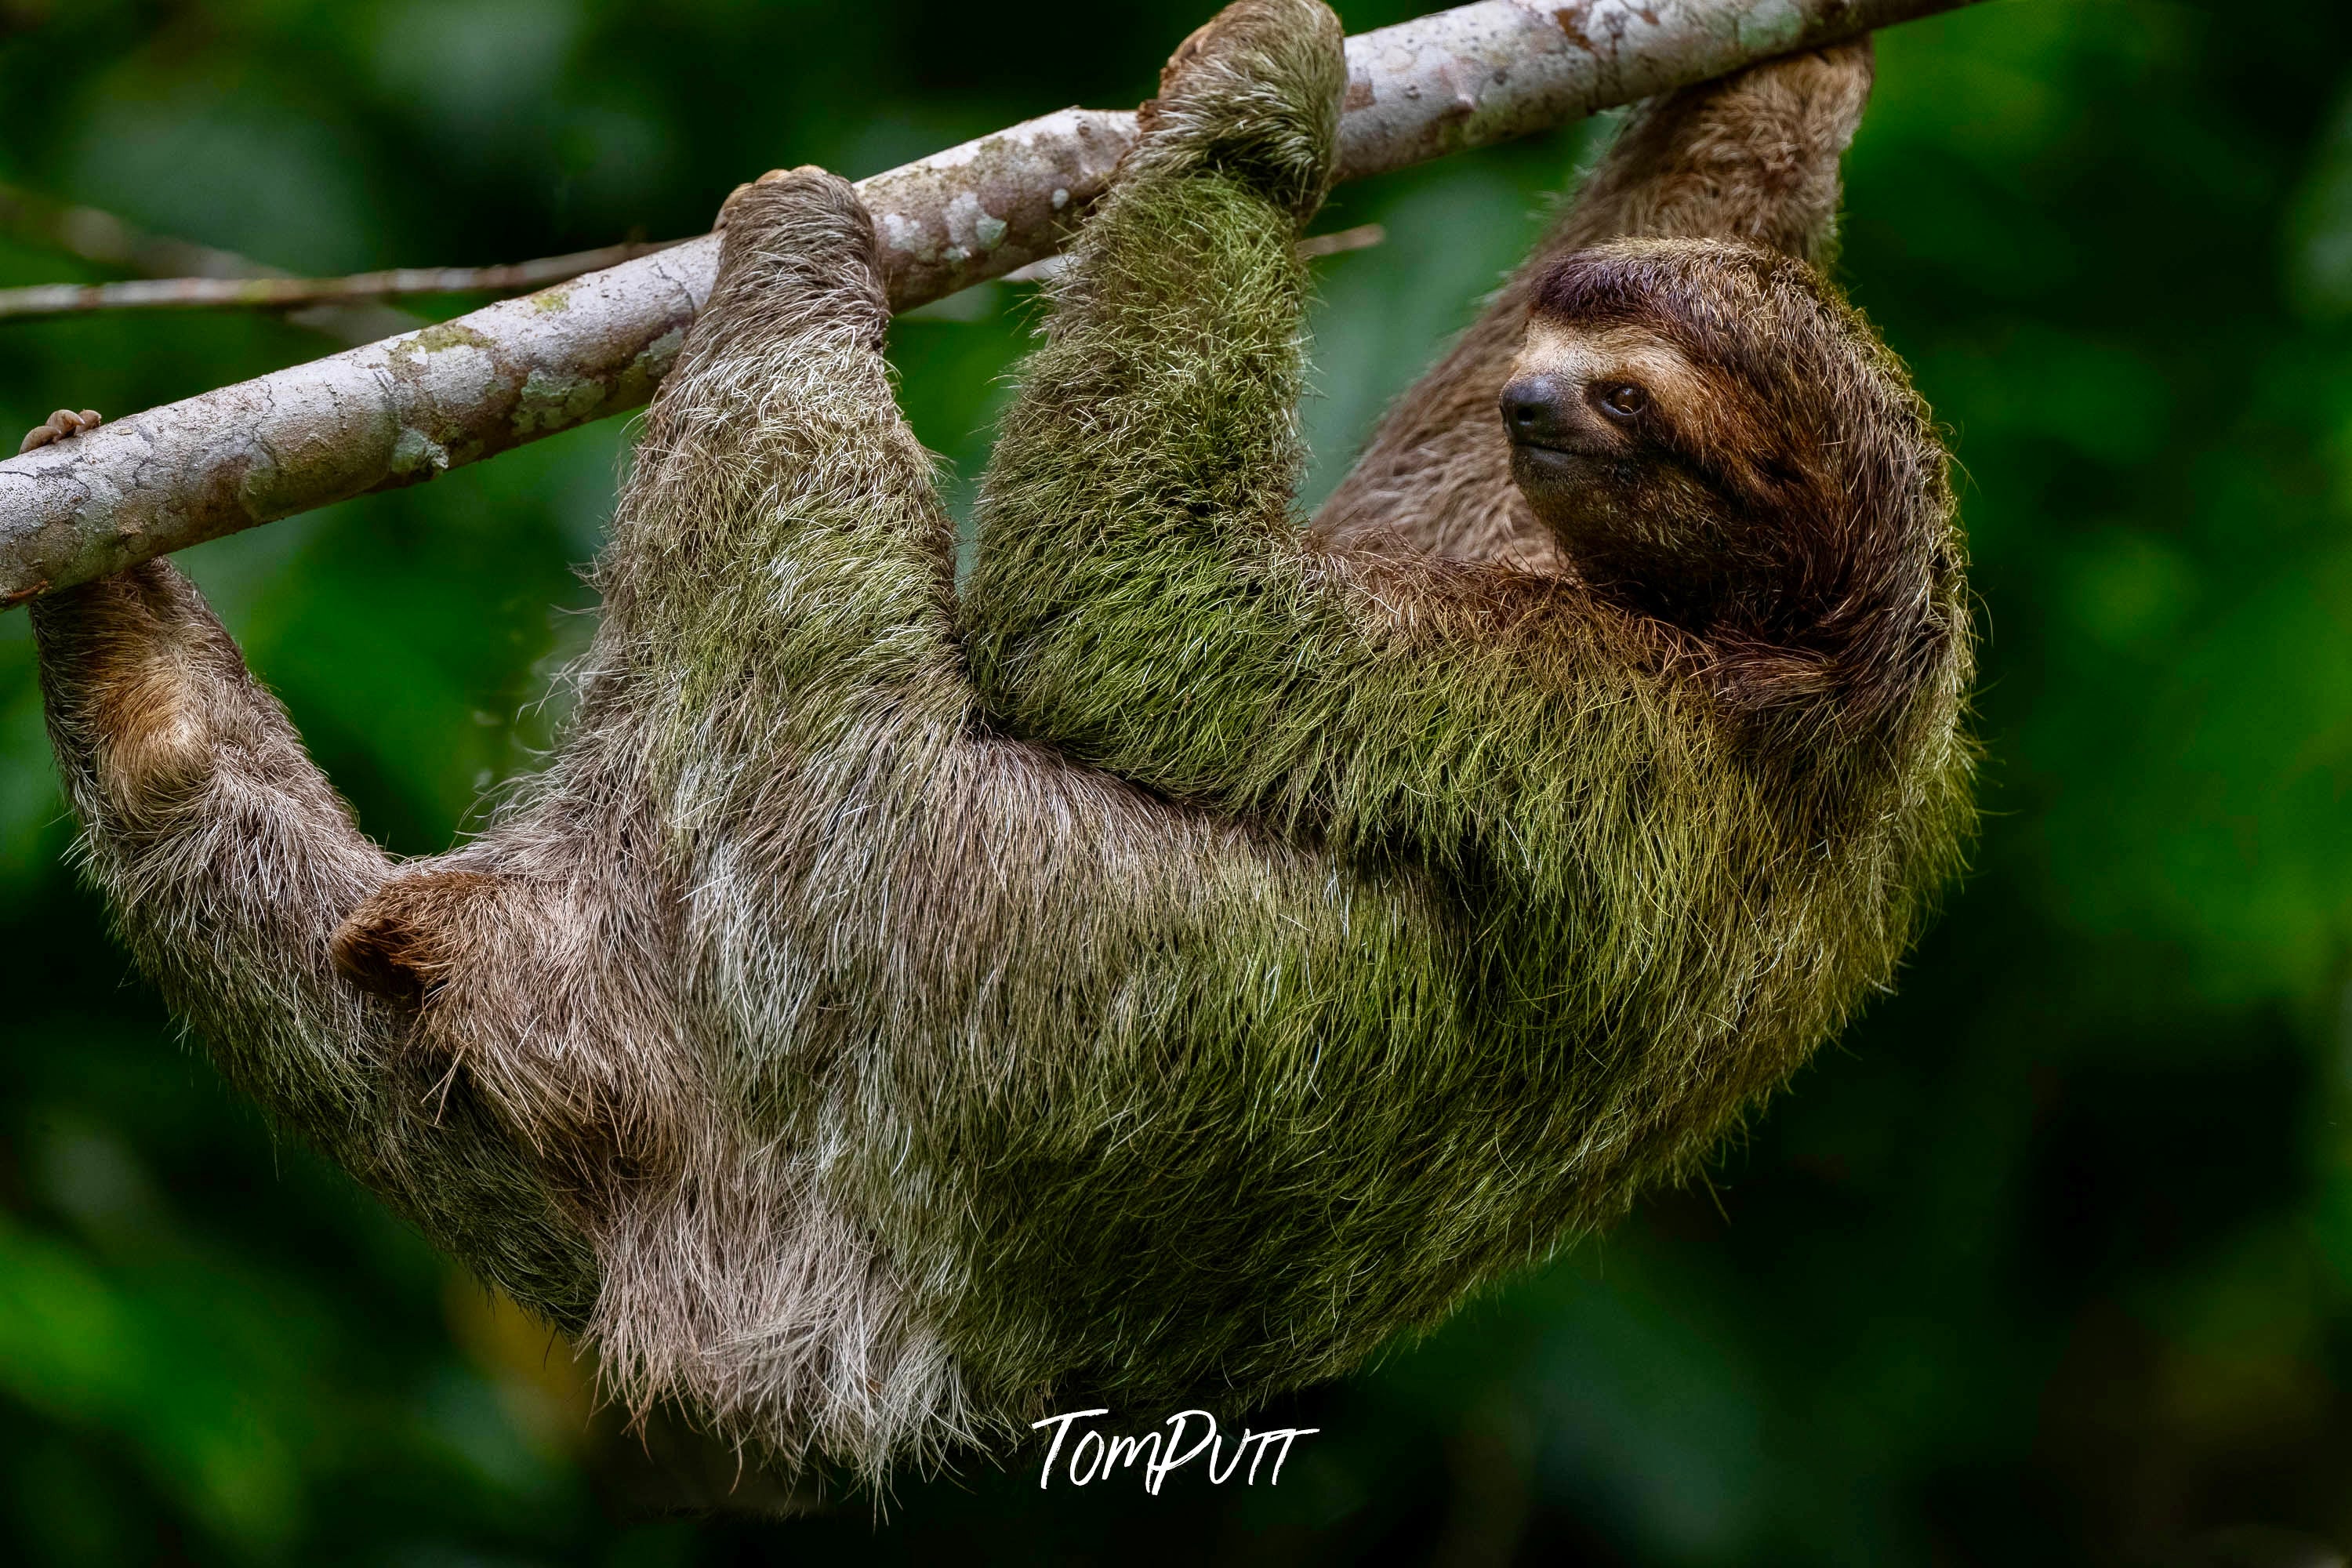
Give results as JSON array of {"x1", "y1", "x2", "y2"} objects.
[{"x1": 0, "y1": 240, "x2": 684, "y2": 320}]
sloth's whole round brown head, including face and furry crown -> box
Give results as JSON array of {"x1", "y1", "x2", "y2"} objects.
[{"x1": 1501, "y1": 240, "x2": 1950, "y2": 662}]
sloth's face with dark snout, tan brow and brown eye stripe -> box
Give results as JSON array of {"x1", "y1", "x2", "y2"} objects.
[{"x1": 1501, "y1": 313, "x2": 1755, "y2": 621}]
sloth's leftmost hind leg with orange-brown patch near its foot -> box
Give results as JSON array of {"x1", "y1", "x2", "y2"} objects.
[{"x1": 31, "y1": 552, "x2": 590, "y2": 1323}]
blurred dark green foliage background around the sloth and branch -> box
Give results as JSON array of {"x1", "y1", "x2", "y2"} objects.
[{"x1": 0, "y1": 0, "x2": 2352, "y2": 1566}]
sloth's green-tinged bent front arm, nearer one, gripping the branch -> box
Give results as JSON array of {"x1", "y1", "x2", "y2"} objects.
[{"x1": 964, "y1": 2, "x2": 1788, "y2": 884}]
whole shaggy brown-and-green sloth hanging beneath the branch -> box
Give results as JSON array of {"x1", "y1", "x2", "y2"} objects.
[{"x1": 31, "y1": 0, "x2": 1971, "y2": 1476}]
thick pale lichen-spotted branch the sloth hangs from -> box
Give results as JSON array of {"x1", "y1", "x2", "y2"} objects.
[{"x1": 0, "y1": 0, "x2": 1973, "y2": 607}]
